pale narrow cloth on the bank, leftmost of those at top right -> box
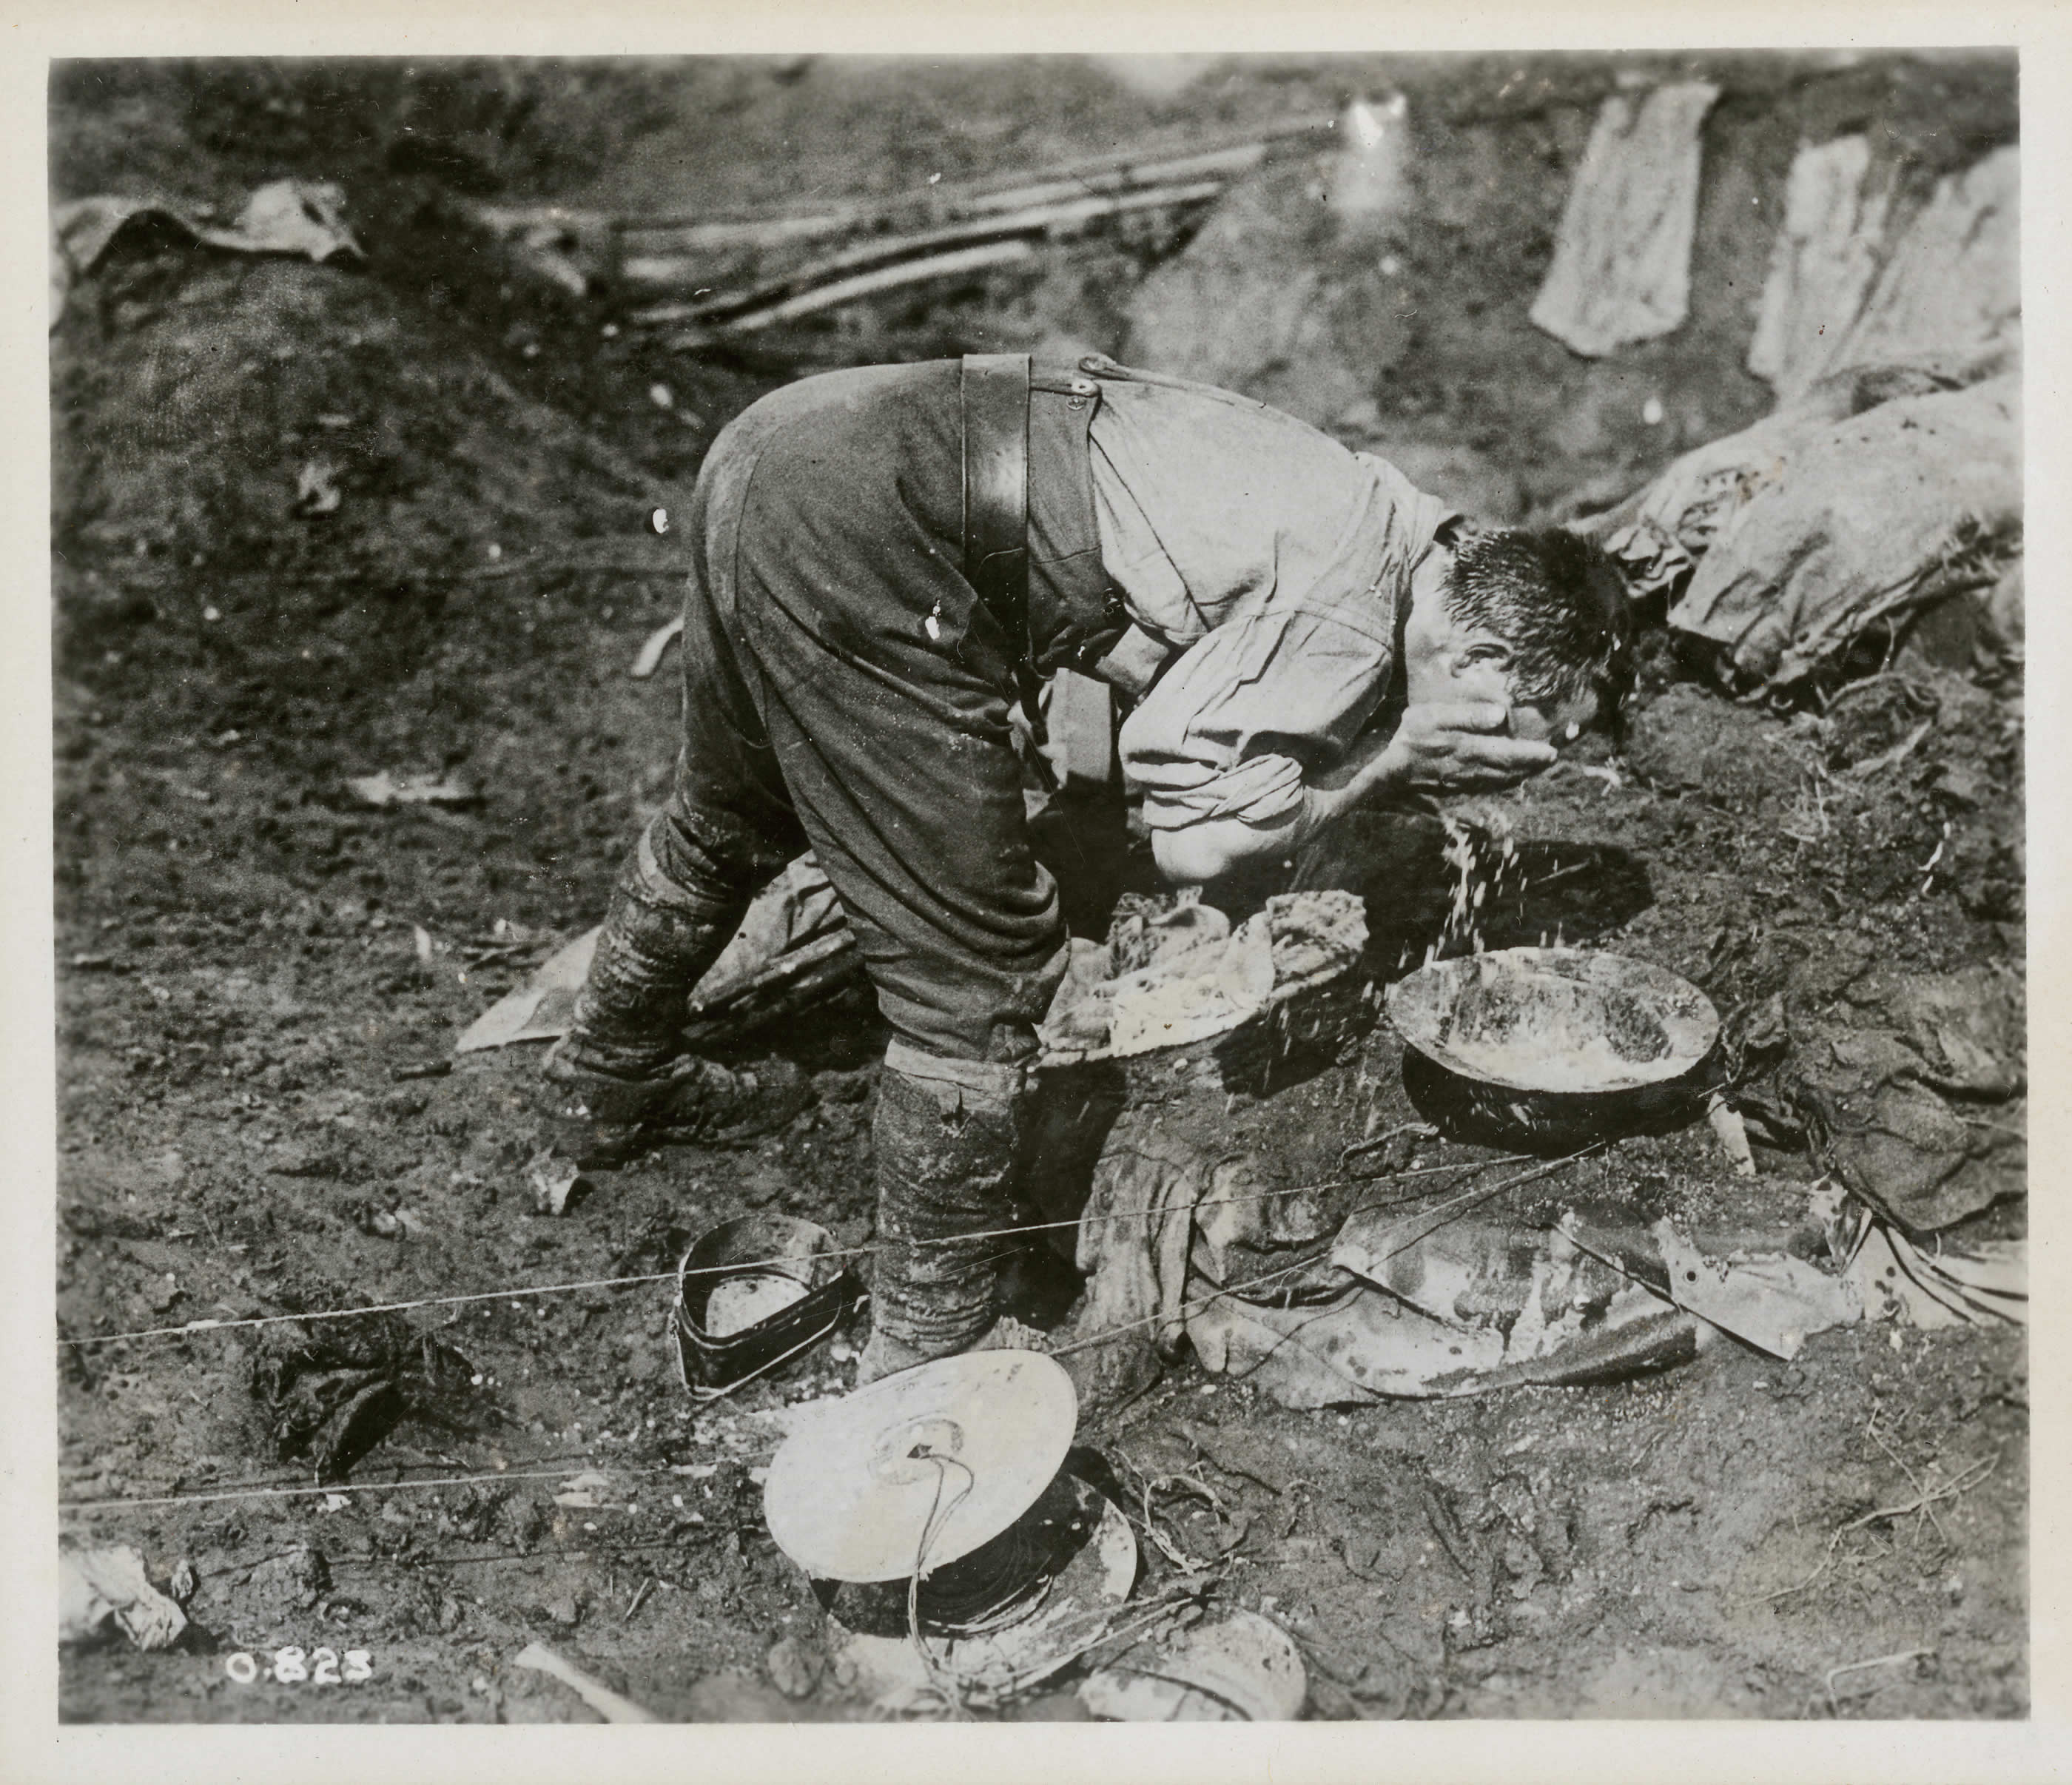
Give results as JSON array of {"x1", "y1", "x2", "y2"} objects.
[{"x1": 1531, "y1": 81, "x2": 1720, "y2": 359}]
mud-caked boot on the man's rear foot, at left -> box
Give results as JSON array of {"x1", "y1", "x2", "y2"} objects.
[{"x1": 541, "y1": 1037, "x2": 813, "y2": 1171}]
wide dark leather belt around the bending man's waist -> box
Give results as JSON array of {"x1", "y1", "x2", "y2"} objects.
[{"x1": 959, "y1": 352, "x2": 1044, "y2": 742}]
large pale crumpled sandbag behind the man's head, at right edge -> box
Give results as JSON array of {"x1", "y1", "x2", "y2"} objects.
[{"x1": 1643, "y1": 373, "x2": 2022, "y2": 684}]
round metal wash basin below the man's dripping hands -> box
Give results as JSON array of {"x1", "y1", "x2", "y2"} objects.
[{"x1": 1388, "y1": 947, "x2": 1720, "y2": 1149}]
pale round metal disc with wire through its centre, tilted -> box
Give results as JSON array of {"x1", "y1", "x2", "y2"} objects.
[{"x1": 762, "y1": 1352, "x2": 1080, "y2": 1580}]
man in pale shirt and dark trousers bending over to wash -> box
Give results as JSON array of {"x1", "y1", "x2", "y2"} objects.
[{"x1": 545, "y1": 354, "x2": 1629, "y2": 1381}]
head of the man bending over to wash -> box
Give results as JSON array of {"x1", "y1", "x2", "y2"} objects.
[{"x1": 1403, "y1": 522, "x2": 1632, "y2": 744}]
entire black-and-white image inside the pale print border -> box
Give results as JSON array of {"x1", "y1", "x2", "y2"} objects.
[{"x1": 32, "y1": 31, "x2": 2041, "y2": 1749}]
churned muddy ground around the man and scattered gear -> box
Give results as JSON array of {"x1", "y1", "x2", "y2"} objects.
[{"x1": 54, "y1": 64, "x2": 2028, "y2": 1723}]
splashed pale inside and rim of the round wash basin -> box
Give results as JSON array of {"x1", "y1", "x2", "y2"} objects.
[{"x1": 1388, "y1": 947, "x2": 1720, "y2": 1095}]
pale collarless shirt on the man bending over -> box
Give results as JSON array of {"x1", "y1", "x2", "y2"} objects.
[{"x1": 1088, "y1": 363, "x2": 1456, "y2": 830}]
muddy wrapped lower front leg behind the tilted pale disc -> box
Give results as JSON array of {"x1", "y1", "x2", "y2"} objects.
[{"x1": 855, "y1": 1043, "x2": 1028, "y2": 1387}]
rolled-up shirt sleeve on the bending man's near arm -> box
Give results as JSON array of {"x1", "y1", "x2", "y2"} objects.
[{"x1": 1121, "y1": 605, "x2": 1393, "y2": 830}]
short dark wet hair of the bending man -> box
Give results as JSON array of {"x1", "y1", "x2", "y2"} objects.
[{"x1": 1446, "y1": 527, "x2": 1632, "y2": 711}]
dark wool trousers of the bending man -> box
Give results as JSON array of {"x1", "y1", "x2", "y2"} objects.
[{"x1": 578, "y1": 360, "x2": 1106, "y2": 1068}]
